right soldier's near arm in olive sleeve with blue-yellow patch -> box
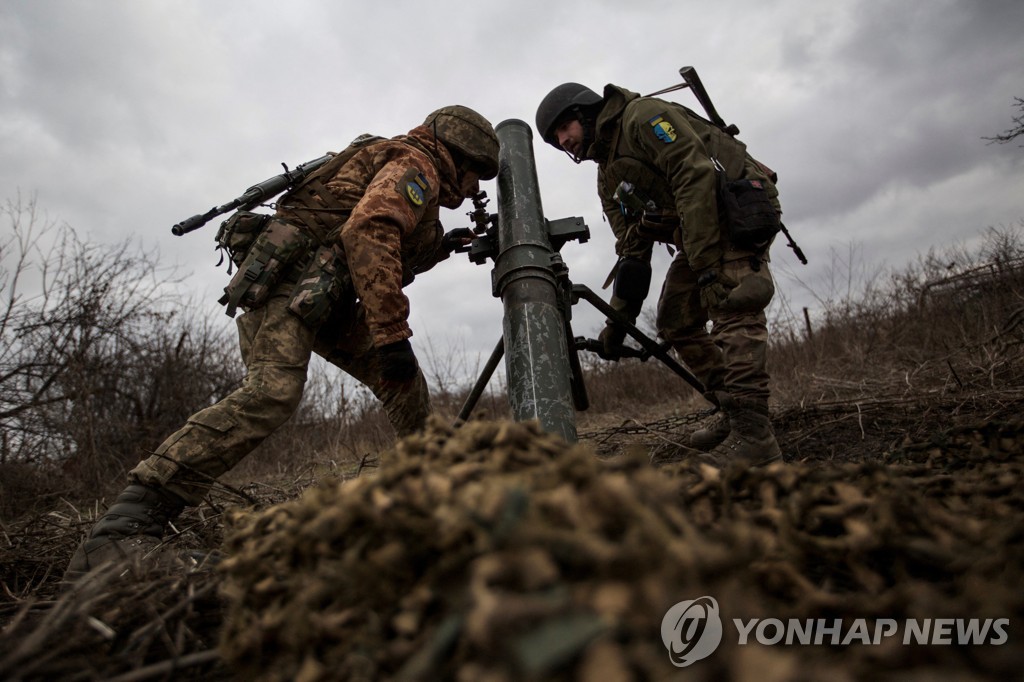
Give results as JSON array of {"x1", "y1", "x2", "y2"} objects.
[{"x1": 626, "y1": 98, "x2": 723, "y2": 271}]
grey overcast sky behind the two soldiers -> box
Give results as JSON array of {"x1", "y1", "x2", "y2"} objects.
[{"x1": 0, "y1": 0, "x2": 1024, "y2": 385}]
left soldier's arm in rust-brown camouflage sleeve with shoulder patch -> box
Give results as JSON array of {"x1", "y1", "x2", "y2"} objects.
[{"x1": 341, "y1": 162, "x2": 437, "y2": 347}]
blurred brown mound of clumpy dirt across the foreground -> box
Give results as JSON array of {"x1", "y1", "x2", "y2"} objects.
[{"x1": 220, "y1": 422, "x2": 1024, "y2": 681}]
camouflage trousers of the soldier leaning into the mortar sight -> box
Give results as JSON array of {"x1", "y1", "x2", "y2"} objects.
[{"x1": 129, "y1": 295, "x2": 430, "y2": 505}]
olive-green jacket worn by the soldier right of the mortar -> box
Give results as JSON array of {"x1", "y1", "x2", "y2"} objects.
[{"x1": 587, "y1": 84, "x2": 778, "y2": 270}]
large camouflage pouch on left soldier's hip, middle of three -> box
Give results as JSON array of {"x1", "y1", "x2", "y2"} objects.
[{"x1": 219, "y1": 218, "x2": 312, "y2": 317}]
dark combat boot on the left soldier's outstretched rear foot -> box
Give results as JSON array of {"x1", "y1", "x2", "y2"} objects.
[{"x1": 63, "y1": 483, "x2": 185, "y2": 582}]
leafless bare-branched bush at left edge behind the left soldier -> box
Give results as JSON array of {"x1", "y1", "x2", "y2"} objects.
[{"x1": 0, "y1": 193, "x2": 240, "y2": 510}]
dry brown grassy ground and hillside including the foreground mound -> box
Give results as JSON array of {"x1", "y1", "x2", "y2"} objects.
[{"x1": 0, "y1": 219, "x2": 1024, "y2": 680}]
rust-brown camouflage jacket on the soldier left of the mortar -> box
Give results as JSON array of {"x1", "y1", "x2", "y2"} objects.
[{"x1": 278, "y1": 126, "x2": 463, "y2": 347}]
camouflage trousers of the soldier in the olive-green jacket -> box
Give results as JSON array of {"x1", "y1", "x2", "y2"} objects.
[{"x1": 656, "y1": 252, "x2": 775, "y2": 404}]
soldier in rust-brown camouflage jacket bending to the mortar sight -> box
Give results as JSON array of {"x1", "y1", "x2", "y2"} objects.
[{"x1": 67, "y1": 105, "x2": 498, "y2": 580}]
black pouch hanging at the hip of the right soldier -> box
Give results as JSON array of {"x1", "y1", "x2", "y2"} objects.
[{"x1": 716, "y1": 170, "x2": 781, "y2": 253}]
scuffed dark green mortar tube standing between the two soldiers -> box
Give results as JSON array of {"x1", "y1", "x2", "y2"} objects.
[{"x1": 492, "y1": 119, "x2": 577, "y2": 442}]
